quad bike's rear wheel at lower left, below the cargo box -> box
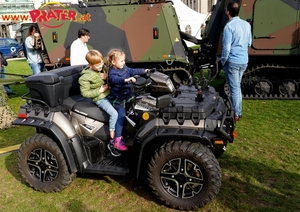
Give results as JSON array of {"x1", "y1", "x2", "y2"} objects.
[{"x1": 18, "y1": 134, "x2": 76, "y2": 192}]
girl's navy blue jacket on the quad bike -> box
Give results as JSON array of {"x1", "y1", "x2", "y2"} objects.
[{"x1": 108, "y1": 65, "x2": 145, "y2": 101}]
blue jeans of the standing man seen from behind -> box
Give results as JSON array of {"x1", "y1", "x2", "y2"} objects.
[{"x1": 224, "y1": 61, "x2": 247, "y2": 116}]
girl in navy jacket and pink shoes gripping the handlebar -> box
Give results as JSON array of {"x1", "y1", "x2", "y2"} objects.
[{"x1": 107, "y1": 49, "x2": 148, "y2": 151}]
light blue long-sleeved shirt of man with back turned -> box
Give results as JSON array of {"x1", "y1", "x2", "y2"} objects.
[{"x1": 221, "y1": 16, "x2": 252, "y2": 65}]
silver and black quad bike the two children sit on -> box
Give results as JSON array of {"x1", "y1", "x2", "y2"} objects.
[{"x1": 13, "y1": 66, "x2": 235, "y2": 210}]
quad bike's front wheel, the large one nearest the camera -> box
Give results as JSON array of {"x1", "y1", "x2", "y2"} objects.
[{"x1": 148, "y1": 141, "x2": 222, "y2": 210}]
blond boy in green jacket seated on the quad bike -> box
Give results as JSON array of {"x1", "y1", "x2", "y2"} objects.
[{"x1": 78, "y1": 50, "x2": 121, "y2": 156}]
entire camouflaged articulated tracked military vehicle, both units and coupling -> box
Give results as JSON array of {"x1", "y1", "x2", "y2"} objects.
[{"x1": 23, "y1": 0, "x2": 300, "y2": 99}]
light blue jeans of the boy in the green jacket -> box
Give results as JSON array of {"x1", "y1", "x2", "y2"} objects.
[{"x1": 95, "y1": 98, "x2": 118, "y2": 131}]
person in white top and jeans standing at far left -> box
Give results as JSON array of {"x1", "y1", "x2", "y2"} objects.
[{"x1": 25, "y1": 26, "x2": 45, "y2": 74}]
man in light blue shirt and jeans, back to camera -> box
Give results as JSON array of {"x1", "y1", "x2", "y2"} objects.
[{"x1": 221, "y1": 1, "x2": 252, "y2": 121}]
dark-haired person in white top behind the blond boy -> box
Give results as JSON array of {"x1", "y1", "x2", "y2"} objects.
[{"x1": 70, "y1": 28, "x2": 90, "y2": 66}]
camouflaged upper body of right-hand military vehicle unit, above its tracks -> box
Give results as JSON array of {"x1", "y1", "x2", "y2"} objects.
[{"x1": 210, "y1": 0, "x2": 300, "y2": 55}]
